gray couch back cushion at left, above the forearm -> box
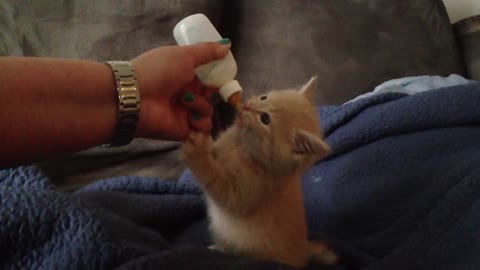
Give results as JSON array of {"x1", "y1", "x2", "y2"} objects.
[{"x1": 0, "y1": 0, "x2": 223, "y2": 61}]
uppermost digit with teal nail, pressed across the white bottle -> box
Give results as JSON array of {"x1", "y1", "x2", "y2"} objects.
[{"x1": 183, "y1": 38, "x2": 231, "y2": 67}]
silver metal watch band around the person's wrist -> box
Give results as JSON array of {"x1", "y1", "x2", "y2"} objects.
[{"x1": 106, "y1": 61, "x2": 140, "y2": 146}]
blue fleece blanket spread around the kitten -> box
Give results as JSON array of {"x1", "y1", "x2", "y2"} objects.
[{"x1": 0, "y1": 84, "x2": 480, "y2": 270}]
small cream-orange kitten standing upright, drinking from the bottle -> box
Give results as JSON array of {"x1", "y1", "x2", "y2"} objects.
[{"x1": 182, "y1": 77, "x2": 337, "y2": 267}]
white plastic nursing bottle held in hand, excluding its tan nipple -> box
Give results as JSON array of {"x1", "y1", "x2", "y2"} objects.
[{"x1": 173, "y1": 14, "x2": 242, "y2": 105}]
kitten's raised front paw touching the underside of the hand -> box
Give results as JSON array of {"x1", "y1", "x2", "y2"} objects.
[{"x1": 182, "y1": 132, "x2": 213, "y2": 166}]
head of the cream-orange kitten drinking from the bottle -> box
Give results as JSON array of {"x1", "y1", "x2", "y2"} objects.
[{"x1": 235, "y1": 77, "x2": 330, "y2": 175}]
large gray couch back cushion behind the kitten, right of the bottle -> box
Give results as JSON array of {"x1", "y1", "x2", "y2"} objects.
[{"x1": 222, "y1": 0, "x2": 464, "y2": 104}]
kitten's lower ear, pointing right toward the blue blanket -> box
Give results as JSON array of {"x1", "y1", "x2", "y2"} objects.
[{"x1": 293, "y1": 130, "x2": 331, "y2": 159}]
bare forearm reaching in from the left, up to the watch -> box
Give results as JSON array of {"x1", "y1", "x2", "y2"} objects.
[{"x1": 0, "y1": 57, "x2": 117, "y2": 167}]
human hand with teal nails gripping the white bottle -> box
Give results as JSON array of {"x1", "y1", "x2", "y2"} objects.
[{"x1": 131, "y1": 42, "x2": 230, "y2": 140}]
